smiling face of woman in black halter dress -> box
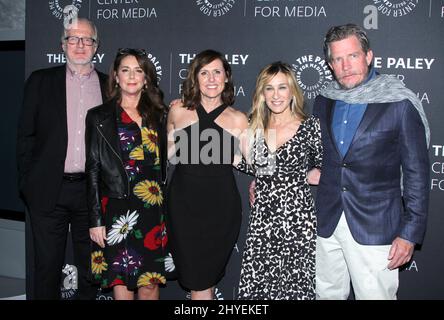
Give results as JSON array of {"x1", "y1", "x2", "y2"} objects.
[{"x1": 197, "y1": 59, "x2": 227, "y2": 99}]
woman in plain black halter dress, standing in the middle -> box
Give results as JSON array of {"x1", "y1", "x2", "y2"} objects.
[{"x1": 167, "y1": 50, "x2": 248, "y2": 300}]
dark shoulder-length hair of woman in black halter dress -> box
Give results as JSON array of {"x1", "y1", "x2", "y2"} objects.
[{"x1": 182, "y1": 50, "x2": 234, "y2": 110}]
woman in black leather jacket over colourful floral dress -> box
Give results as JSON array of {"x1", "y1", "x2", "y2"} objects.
[{"x1": 85, "y1": 49, "x2": 170, "y2": 299}]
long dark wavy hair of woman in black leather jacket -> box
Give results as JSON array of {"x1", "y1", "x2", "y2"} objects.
[{"x1": 108, "y1": 49, "x2": 167, "y2": 127}]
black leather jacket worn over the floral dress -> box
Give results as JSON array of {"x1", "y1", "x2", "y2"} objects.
[{"x1": 85, "y1": 100, "x2": 167, "y2": 228}]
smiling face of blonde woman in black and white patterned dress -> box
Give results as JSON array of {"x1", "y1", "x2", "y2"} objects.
[{"x1": 263, "y1": 72, "x2": 292, "y2": 114}]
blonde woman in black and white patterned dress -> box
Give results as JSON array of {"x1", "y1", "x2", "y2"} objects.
[{"x1": 237, "y1": 62, "x2": 322, "y2": 300}]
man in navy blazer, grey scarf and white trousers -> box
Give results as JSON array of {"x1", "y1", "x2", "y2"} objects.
[{"x1": 313, "y1": 24, "x2": 429, "y2": 299}]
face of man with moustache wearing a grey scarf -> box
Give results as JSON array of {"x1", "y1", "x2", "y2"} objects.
[{"x1": 329, "y1": 36, "x2": 373, "y2": 89}]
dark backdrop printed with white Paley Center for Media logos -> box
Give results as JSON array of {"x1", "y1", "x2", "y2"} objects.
[{"x1": 26, "y1": 0, "x2": 444, "y2": 299}]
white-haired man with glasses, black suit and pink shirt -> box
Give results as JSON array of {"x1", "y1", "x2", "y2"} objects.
[{"x1": 17, "y1": 18, "x2": 106, "y2": 299}]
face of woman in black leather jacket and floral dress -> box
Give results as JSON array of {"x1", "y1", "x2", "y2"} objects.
[{"x1": 115, "y1": 55, "x2": 146, "y2": 96}]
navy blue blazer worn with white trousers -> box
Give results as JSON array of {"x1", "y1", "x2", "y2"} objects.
[{"x1": 313, "y1": 96, "x2": 429, "y2": 245}]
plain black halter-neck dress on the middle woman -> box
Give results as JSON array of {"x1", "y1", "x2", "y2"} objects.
[{"x1": 167, "y1": 105, "x2": 242, "y2": 291}]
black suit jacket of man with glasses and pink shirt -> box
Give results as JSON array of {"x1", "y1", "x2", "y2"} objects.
[{"x1": 17, "y1": 65, "x2": 107, "y2": 211}]
